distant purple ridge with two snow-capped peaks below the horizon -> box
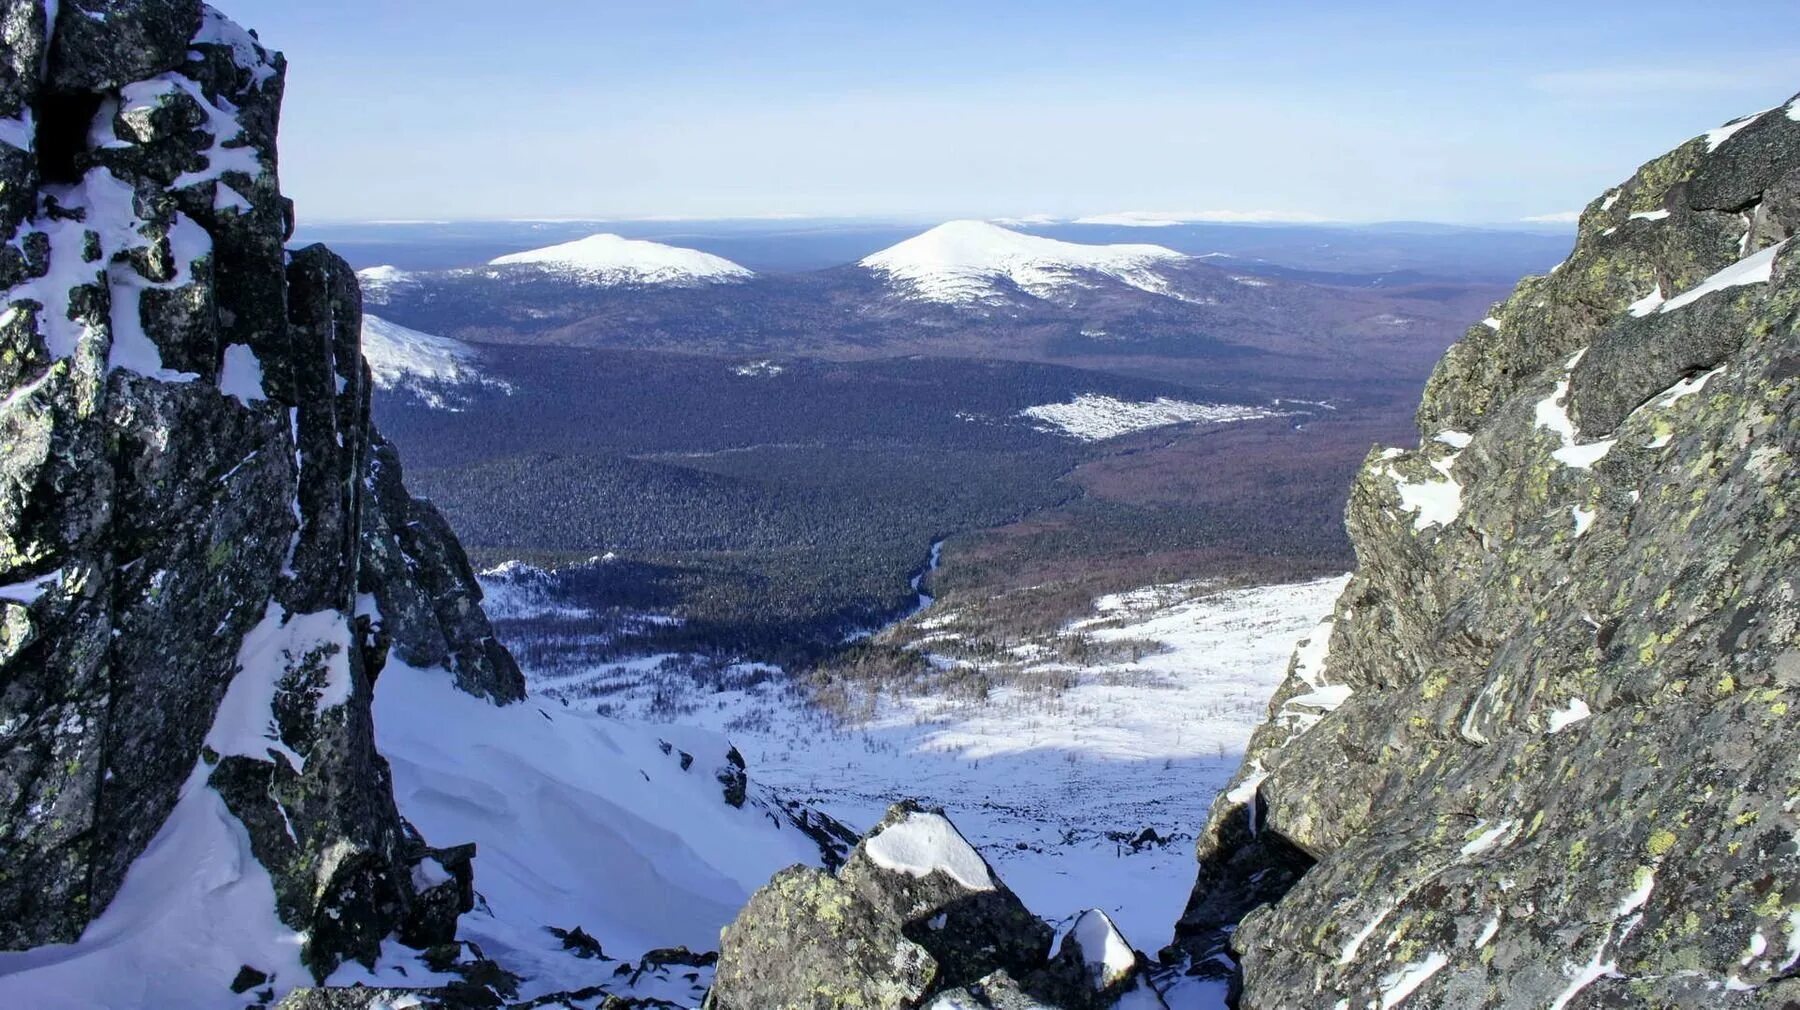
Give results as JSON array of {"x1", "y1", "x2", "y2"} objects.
[{"x1": 360, "y1": 221, "x2": 1503, "y2": 378}]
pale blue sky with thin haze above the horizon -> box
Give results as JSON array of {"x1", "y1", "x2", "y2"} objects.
[{"x1": 214, "y1": 0, "x2": 1800, "y2": 223}]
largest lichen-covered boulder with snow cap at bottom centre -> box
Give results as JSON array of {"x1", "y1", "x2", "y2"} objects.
[{"x1": 707, "y1": 803, "x2": 1051, "y2": 1010}]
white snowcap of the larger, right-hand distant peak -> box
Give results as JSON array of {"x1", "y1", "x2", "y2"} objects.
[{"x1": 860, "y1": 221, "x2": 1186, "y2": 304}]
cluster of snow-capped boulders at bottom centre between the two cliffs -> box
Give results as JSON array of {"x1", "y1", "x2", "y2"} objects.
[{"x1": 706, "y1": 803, "x2": 1163, "y2": 1010}]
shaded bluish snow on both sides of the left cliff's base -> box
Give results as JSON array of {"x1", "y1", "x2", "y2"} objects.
[{"x1": 0, "y1": 657, "x2": 819, "y2": 1010}]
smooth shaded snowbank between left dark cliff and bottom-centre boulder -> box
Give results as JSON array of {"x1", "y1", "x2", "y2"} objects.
[{"x1": 374, "y1": 659, "x2": 819, "y2": 1001}]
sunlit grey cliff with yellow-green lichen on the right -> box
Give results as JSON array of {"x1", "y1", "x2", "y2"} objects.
[{"x1": 1172, "y1": 101, "x2": 1800, "y2": 1010}]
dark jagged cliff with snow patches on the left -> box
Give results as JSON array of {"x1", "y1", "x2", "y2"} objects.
[{"x1": 0, "y1": 0, "x2": 524, "y2": 985}]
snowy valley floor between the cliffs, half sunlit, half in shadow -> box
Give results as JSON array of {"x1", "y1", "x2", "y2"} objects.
[{"x1": 511, "y1": 578, "x2": 1345, "y2": 951}]
